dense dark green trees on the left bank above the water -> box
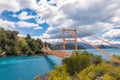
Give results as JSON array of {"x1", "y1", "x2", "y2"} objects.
[{"x1": 0, "y1": 28, "x2": 43, "y2": 56}]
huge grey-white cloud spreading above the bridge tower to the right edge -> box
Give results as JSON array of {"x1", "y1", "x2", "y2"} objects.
[{"x1": 37, "y1": 0, "x2": 120, "y2": 38}]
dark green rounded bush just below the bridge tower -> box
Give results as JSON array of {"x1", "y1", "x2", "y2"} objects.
[{"x1": 64, "y1": 51, "x2": 93, "y2": 75}]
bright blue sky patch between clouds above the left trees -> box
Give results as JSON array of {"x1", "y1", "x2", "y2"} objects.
[{"x1": 0, "y1": 8, "x2": 49, "y2": 36}]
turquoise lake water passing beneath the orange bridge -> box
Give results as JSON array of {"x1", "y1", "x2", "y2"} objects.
[{"x1": 0, "y1": 49, "x2": 120, "y2": 80}]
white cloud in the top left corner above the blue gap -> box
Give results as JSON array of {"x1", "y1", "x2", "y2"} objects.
[{"x1": 0, "y1": 0, "x2": 38, "y2": 13}]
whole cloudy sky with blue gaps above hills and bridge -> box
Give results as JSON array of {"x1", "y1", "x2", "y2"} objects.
[{"x1": 0, "y1": 0, "x2": 120, "y2": 44}]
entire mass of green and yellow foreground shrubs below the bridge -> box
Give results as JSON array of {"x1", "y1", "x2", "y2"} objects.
[{"x1": 49, "y1": 51, "x2": 120, "y2": 80}]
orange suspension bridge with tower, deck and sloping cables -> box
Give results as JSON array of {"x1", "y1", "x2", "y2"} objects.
[{"x1": 42, "y1": 28, "x2": 120, "y2": 63}]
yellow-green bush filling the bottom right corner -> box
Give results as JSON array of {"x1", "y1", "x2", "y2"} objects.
[{"x1": 77, "y1": 63, "x2": 120, "y2": 80}]
